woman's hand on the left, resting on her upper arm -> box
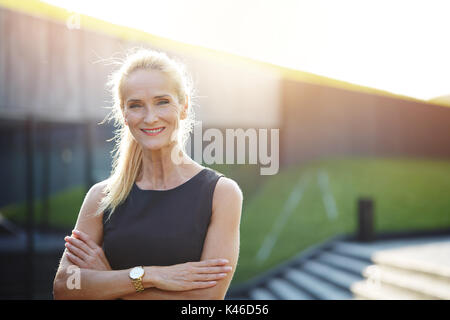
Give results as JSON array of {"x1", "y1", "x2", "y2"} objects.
[{"x1": 64, "y1": 230, "x2": 111, "y2": 271}]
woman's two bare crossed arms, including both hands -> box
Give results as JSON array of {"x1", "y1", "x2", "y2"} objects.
[{"x1": 53, "y1": 177, "x2": 243, "y2": 300}]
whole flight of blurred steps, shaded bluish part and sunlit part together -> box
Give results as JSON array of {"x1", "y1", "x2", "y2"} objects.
[{"x1": 226, "y1": 235, "x2": 450, "y2": 300}]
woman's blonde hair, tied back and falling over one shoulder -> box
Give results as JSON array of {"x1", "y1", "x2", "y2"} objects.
[{"x1": 97, "y1": 48, "x2": 195, "y2": 216}]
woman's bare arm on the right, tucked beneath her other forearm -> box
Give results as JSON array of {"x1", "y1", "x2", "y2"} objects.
[{"x1": 123, "y1": 177, "x2": 243, "y2": 300}]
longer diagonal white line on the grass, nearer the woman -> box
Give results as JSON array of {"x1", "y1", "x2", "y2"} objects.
[{"x1": 256, "y1": 174, "x2": 310, "y2": 264}]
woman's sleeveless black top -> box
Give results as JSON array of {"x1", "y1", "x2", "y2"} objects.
[{"x1": 103, "y1": 168, "x2": 223, "y2": 270}]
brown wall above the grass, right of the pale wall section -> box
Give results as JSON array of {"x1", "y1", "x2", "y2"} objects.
[{"x1": 280, "y1": 80, "x2": 450, "y2": 165}]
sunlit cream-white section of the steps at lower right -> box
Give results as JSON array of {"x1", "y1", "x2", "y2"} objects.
[{"x1": 351, "y1": 241, "x2": 450, "y2": 300}]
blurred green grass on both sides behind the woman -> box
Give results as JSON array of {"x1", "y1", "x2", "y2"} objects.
[{"x1": 0, "y1": 158, "x2": 450, "y2": 284}]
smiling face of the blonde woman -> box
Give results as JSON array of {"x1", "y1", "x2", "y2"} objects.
[{"x1": 122, "y1": 70, "x2": 186, "y2": 150}]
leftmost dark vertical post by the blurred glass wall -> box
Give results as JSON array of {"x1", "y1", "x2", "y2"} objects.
[{"x1": 24, "y1": 116, "x2": 34, "y2": 299}]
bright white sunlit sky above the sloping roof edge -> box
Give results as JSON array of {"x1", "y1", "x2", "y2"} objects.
[{"x1": 40, "y1": 0, "x2": 450, "y2": 100}]
